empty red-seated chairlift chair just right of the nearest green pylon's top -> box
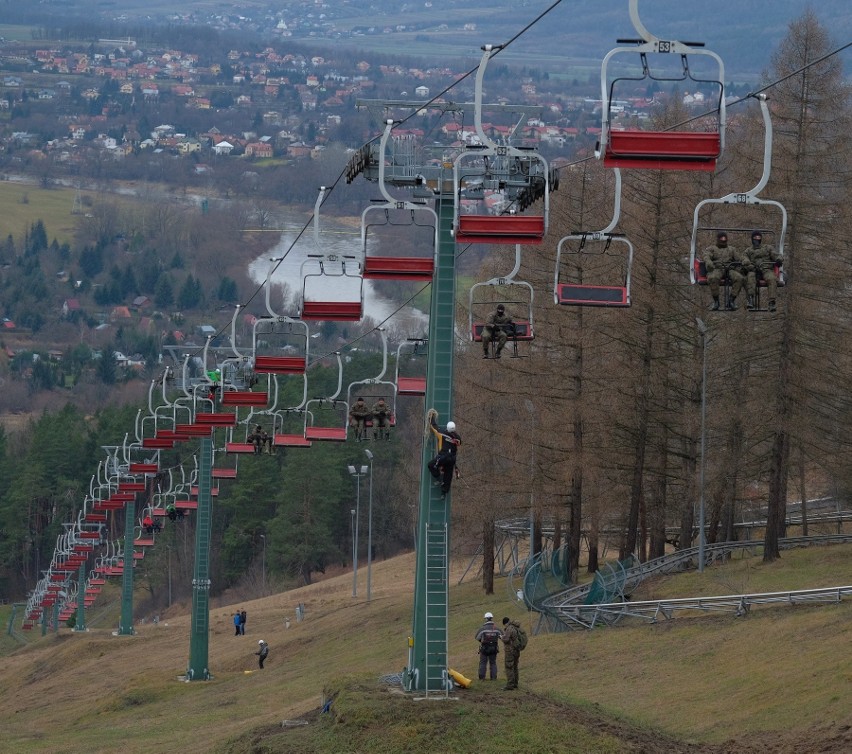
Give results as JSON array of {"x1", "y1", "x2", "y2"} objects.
[{"x1": 453, "y1": 45, "x2": 551, "y2": 244}]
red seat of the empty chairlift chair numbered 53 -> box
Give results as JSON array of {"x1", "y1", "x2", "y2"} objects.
[{"x1": 604, "y1": 129, "x2": 722, "y2": 172}]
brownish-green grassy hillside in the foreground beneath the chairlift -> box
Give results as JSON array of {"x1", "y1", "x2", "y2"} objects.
[{"x1": 0, "y1": 547, "x2": 852, "y2": 754}]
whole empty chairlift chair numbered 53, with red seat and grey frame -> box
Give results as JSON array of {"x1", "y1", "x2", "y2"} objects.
[{"x1": 596, "y1": 0, "x2": 726, "y2": 171}]
